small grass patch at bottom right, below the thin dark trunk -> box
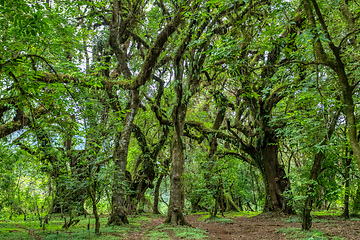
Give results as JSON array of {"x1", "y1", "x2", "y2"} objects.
[{"x1": 278, "y1": 228, "x2": 345, "y2": 240}]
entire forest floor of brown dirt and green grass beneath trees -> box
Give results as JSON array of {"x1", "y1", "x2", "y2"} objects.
[{"x1": 0, "y1": 212, "x2": 360, "y2": 240}]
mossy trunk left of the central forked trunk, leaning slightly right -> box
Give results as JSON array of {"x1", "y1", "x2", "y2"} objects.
[{"x1": 108, "y1": 90, "x2": 140, "y2": 226}]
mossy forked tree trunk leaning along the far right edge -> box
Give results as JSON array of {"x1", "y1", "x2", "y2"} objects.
[{"x1": 303, "y1": 0, "x2": 360, "y2": 174}]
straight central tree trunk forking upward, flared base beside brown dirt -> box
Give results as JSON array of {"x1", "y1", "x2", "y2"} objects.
[{"x1": 165, "y1": 7, "x2": 210, "y2": 223}]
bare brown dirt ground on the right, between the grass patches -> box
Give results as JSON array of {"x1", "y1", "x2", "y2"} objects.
[{"x1": 137, "y1": 215, "x2": 360, "y2": 240}]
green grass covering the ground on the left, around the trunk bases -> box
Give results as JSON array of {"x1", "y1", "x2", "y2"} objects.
[{"x1": 0, "y1": 215, "x2": 208, "y2": 240}]
